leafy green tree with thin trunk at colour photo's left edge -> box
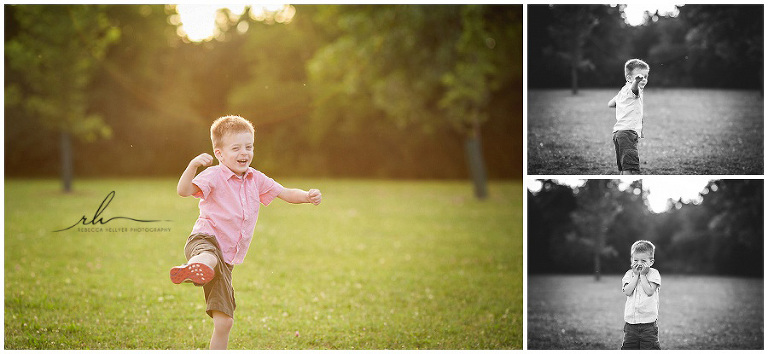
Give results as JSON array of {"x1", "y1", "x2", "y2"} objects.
[{"x1": 5, "y1": 5, "x2": 120, "y2": 192}]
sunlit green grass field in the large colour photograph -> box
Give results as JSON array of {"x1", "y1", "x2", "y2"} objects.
[{"x1": 5, "y1": 179, "x2": 523, "y2": 349}]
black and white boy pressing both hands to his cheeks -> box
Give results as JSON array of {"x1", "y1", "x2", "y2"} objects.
[{"x1": 621, "y1": 240, "x2": 661, "y2": 349}]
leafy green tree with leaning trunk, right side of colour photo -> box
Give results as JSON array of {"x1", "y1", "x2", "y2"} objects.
[{"x1": 308, "y1": 6, "x2": 522, "y2": 199}]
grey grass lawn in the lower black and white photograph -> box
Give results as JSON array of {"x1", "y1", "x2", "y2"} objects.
[{"x1": 527, "y1": 274, "x2": 764, "y2": 350}]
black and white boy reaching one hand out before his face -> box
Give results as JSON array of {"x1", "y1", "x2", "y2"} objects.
[{"x1": 608, "y1": 59, "x2": 650, "y2": 175}]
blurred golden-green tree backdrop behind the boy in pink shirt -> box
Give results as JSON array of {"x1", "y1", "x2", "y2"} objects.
[{"x1": 5, "y1": 5, "x2": 523, "y2": 185}]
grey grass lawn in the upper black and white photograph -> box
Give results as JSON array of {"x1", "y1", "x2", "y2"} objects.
[{"x1": 528, "y1": 86, "x2": 764, "y2": 175}]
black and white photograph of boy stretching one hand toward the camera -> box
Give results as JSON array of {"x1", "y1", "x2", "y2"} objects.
[{"x1": 526, "y1": 3, "x2": 764, "y2": 175}]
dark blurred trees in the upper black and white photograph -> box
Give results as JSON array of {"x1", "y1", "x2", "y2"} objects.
[{"x1": 527, "y1": 4, "x2": 764, "y2": 90}]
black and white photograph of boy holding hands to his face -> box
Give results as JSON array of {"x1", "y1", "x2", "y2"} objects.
[{"x1": 526, "y1": 176, "x2": 764, "y2": 350}]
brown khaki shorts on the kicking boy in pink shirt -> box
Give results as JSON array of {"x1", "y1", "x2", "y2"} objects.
[{"x1": 184, "y1": 234, "x2": 237, "y2": 317}]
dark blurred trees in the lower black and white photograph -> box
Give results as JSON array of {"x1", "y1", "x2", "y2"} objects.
[{"x1": 527, "y1": 179, "x2": 764, "y2": 277}]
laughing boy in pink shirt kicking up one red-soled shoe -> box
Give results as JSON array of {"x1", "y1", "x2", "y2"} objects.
[{"x1": 170, "y1": 116, "x2": 322, "y2": 349}]
